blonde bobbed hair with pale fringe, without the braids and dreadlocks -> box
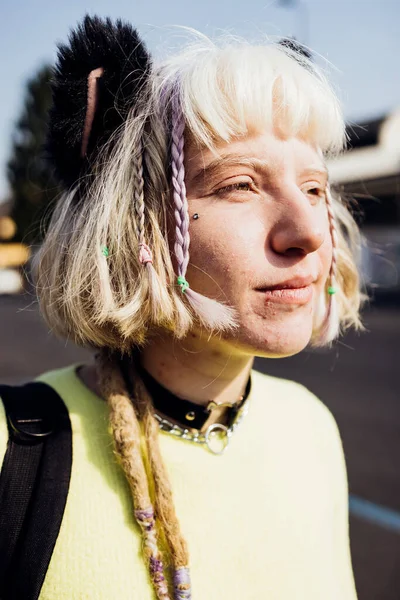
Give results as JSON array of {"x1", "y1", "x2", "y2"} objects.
[{"x1": 35, "y1": 36, "x2": 360, "y2": 349}]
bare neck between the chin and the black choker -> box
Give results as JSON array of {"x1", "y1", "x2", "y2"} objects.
[{"x1": 141, "y1": 333, "x2": 254, "y2": 427}]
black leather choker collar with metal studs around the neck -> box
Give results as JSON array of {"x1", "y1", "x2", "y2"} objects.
[{"x1": 121, "y1": 361, "x2": 251, "y2": 430}]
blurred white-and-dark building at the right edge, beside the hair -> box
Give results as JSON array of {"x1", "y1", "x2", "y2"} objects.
[{"x1": 328, "y1": 109, "x2": 400, "y2": 298}]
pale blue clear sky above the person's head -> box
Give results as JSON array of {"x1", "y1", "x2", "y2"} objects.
[{"x1": 0, "y1": 0, "x2": 400, "y2": 201}]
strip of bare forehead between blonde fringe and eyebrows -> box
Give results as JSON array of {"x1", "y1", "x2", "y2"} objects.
[{"x1": 185, "y1": 129, "x2": 326, "y2": 183}]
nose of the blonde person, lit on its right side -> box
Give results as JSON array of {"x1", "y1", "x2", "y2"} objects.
[{"x1": 269, "y1": 187, "x2": 328, "y2": 256}]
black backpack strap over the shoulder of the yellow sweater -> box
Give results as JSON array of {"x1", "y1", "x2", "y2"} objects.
[{"x1": 0, "y1": 382, "x2": 72, "y2": 600}]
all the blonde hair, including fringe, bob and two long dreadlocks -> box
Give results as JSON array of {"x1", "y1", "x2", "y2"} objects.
[{"x1": 34, "y1": 27, "x2": 361, "y2": 600}]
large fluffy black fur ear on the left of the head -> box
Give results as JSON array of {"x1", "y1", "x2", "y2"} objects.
[{"x1": 46, "y1": 16, "x2": 151, "y2": 188}]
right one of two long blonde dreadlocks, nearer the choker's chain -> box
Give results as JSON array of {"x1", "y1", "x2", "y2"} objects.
[{"x1": 133, "y1": 360, "x2": 192, "y2": 600}]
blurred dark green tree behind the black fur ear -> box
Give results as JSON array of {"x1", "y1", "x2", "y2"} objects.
[{"x1": 7, "y1": 65, "x2": 60, "y2": 243}]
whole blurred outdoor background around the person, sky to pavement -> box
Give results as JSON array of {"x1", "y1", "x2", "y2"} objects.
[{"x1": 0, "y1": 0, "x2": 400, "y2": 600}]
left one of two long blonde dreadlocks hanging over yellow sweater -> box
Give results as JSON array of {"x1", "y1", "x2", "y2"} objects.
[{"x1": 96, "y1": 352, "x2": 170, "y2": 600}]
